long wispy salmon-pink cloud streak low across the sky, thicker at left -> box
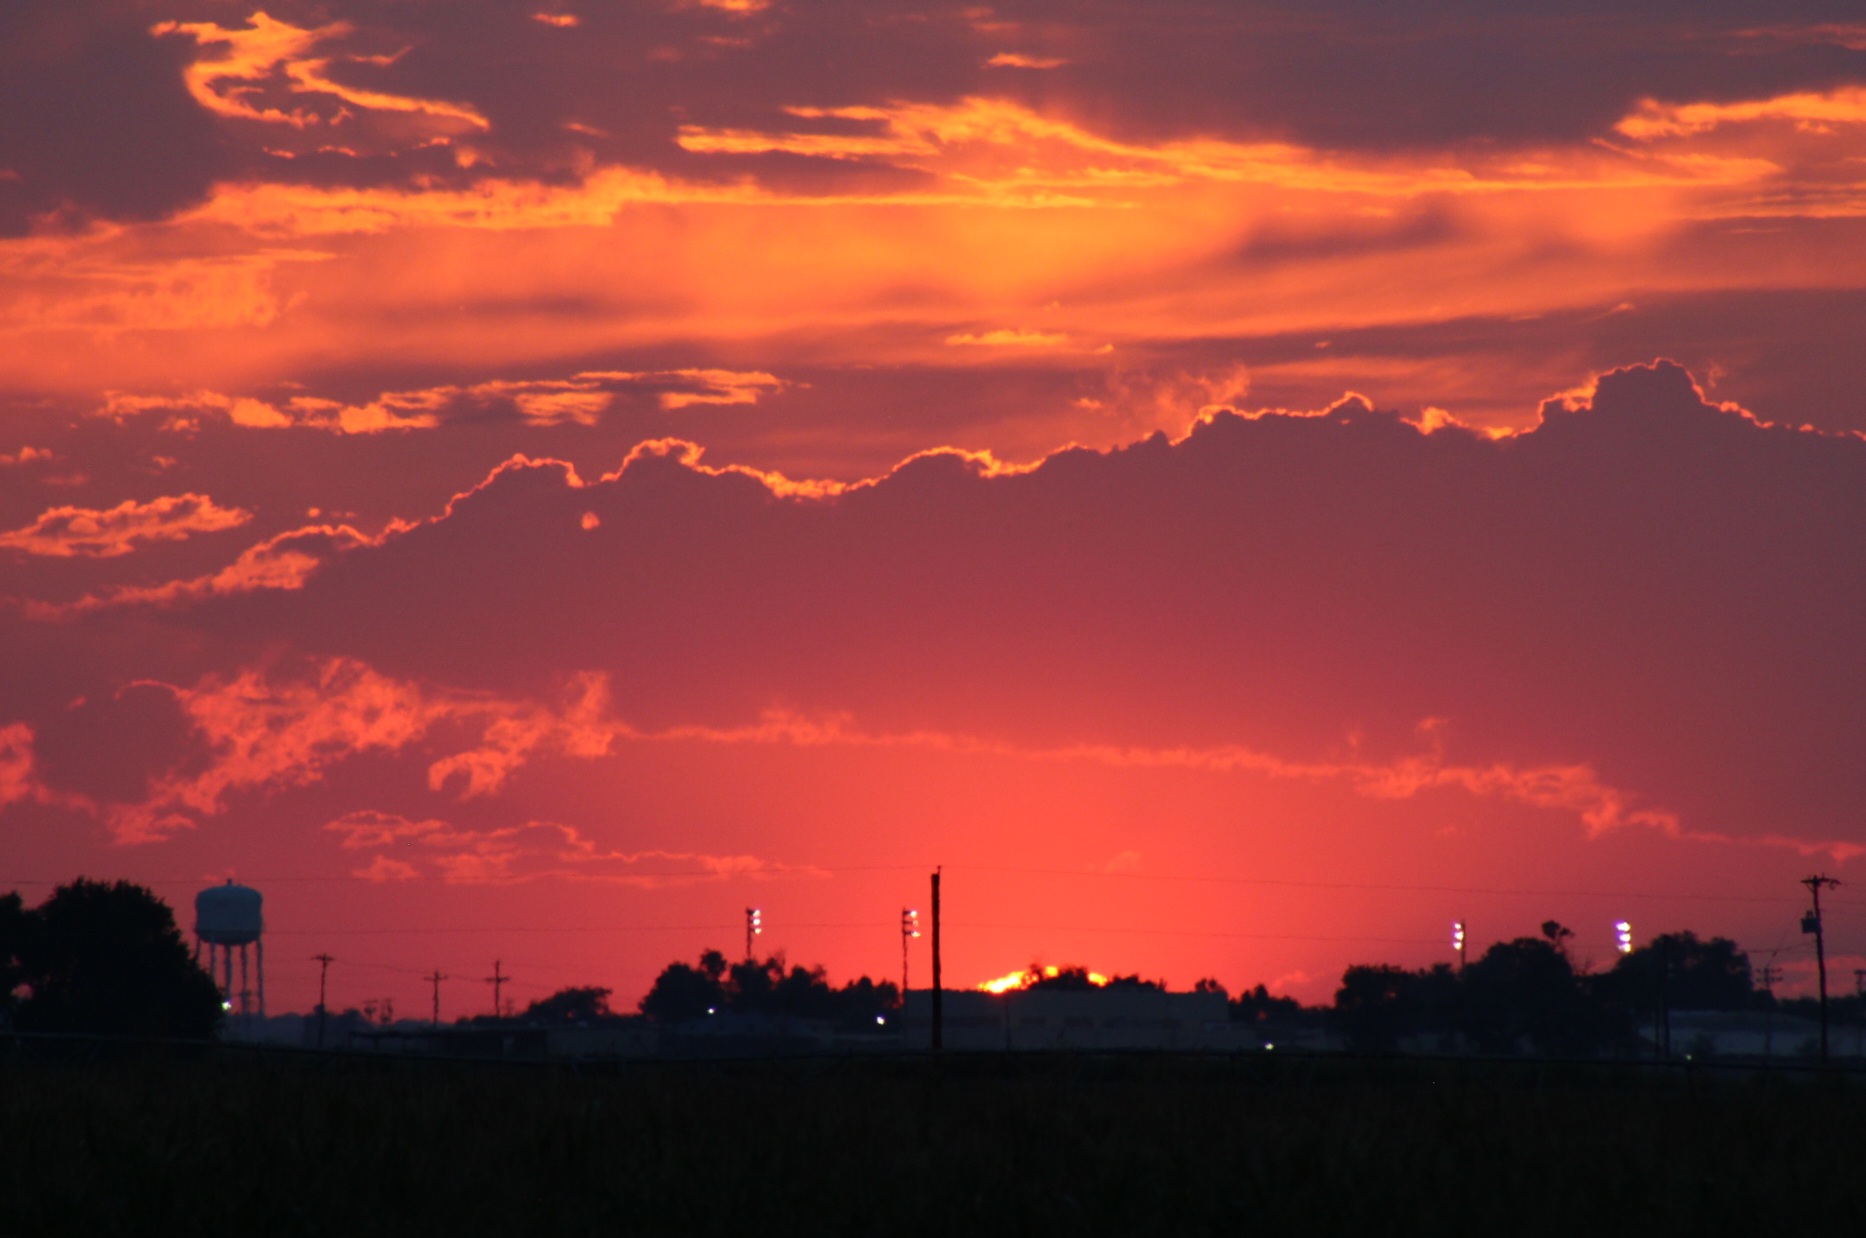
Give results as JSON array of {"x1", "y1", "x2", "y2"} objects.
[{"x1": 90, "y1": 659, "x2": 1866, "y2": 862}]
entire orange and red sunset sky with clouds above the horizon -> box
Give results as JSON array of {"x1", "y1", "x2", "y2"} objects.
[{"x1": 0, "y1": 0, "x2": 1866, "y2": 1014}]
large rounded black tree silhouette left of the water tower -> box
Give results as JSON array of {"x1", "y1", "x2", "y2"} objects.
[{"x1": 0, "y1": 878, "x2": 222, "y2": 1038}]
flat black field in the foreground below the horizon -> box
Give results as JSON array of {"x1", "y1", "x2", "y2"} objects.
[{"x1": 0, "y1": 1053, "x2": 1866, "y2": 1238}]
